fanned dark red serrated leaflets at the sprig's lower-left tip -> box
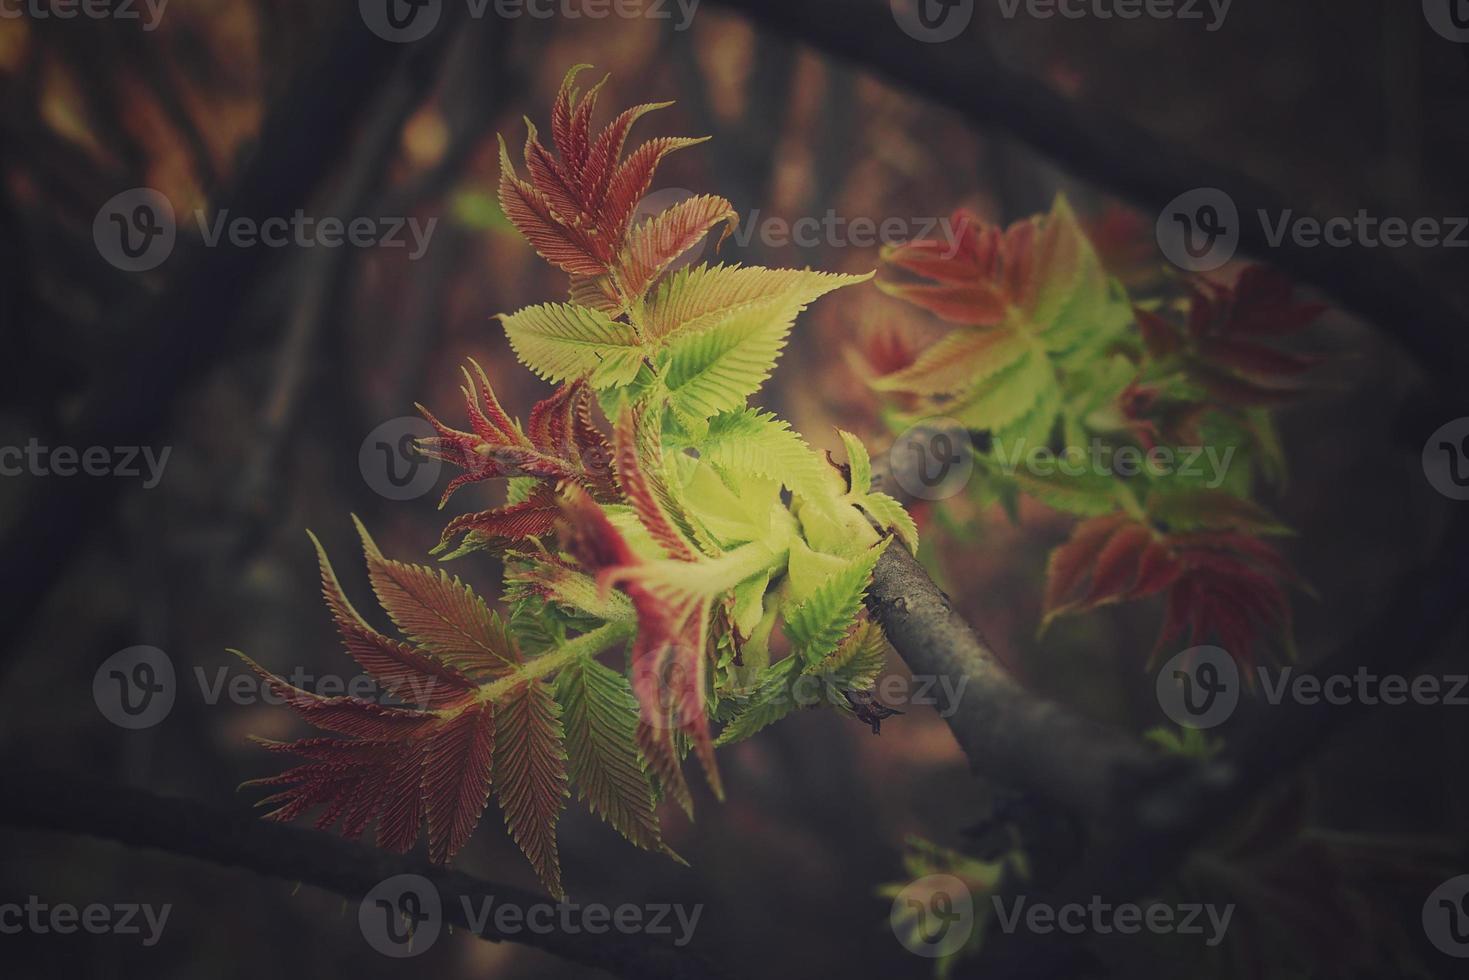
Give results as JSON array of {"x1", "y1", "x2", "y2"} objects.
[{"x1": 237, "y1": 528, "x2": 521, "y2": 862}]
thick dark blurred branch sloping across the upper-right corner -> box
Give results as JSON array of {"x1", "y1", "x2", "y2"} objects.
[{"x1": 718, "y1": 0, "x2": 1469, "y2": 379}]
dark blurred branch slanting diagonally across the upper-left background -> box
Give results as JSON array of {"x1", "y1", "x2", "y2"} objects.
[{"x1": 0, "y1": 6, "x2": 470, "y2": 658}]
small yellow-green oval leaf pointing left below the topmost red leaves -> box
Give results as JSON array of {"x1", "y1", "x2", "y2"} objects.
[{"x1": 499, "y1": 303, "x2": 643, "y2": 388}]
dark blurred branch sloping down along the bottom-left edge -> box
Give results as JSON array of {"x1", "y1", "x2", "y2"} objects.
[{"x1": 0, "y1": 760, "x2": 723, "y2": 980}]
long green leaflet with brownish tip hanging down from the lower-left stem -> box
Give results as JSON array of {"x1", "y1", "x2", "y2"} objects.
[{"x1": 555, "y1": 657, "x2": 664, "y2": 851}]
